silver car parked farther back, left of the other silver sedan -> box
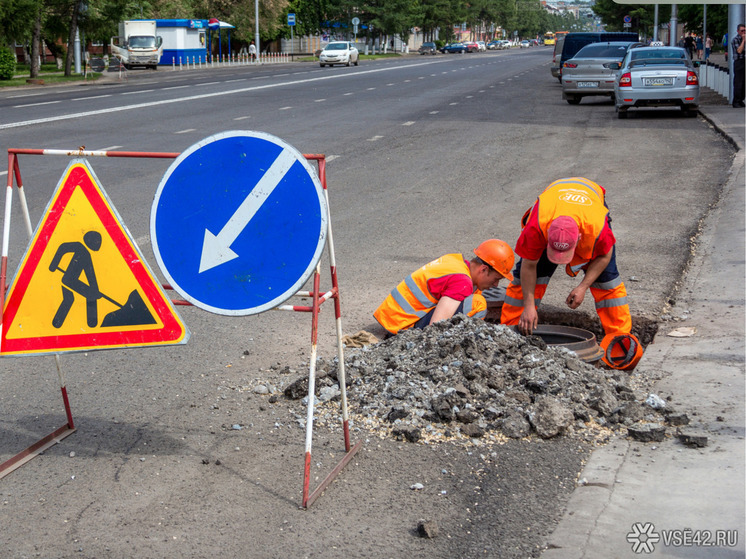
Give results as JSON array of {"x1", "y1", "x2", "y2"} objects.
[{"x1": 561, "y1": 41, "x2": 642, "y2": 105}]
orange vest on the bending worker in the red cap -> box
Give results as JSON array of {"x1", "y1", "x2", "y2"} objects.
[{"x1": 537, "y1": 177, "x2": 609, "y2": 269}]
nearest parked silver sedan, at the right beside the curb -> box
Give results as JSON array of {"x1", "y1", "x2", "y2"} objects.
[{"x1": 611, "y1": 47, "x2": 699, "y2": 118}]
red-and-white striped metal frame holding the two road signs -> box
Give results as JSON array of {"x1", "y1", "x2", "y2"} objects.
[{"x1": 0, "y1": 147, "x2": 362, "y2": 509}]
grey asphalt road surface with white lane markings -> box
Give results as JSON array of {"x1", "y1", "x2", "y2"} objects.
[{"x1": 0, "y1": 48, "x2": 732, "y2": 557}]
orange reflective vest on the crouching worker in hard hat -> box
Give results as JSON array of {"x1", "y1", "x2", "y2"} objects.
[{"x1": 373, "y1": 254, "x2": 487, "y2": 334}]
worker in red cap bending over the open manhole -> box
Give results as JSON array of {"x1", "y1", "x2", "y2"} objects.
[{"x1": 500, "y1": 177, "x2": 642, "y2": 369}]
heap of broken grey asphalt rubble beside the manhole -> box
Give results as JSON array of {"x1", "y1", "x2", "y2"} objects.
[{"x1": 284, "y1": 315, "x2": 680, "y2": 445}]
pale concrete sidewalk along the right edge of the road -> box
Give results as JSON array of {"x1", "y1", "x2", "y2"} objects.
[{"x1": 542, "y1": 105, "x2": 746, "y2": 559}]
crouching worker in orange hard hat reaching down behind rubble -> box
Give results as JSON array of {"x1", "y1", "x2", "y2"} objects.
[{"x1": 373, "y1": 239, "x2": 515, "y2": 334}]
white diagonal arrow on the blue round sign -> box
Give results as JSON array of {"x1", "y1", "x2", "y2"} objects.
[{"x1": 199, "y1": 149, "x2": 297, "y2": 274}]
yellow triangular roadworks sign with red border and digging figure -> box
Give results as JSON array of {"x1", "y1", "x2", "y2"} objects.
[{"x1": 0, "y1": 159, "x2": 189, "y2": 355}]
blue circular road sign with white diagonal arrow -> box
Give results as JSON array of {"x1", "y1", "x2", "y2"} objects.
[{"x1": 150, "y1": 131, "x2": 328, "y2": 315}]
